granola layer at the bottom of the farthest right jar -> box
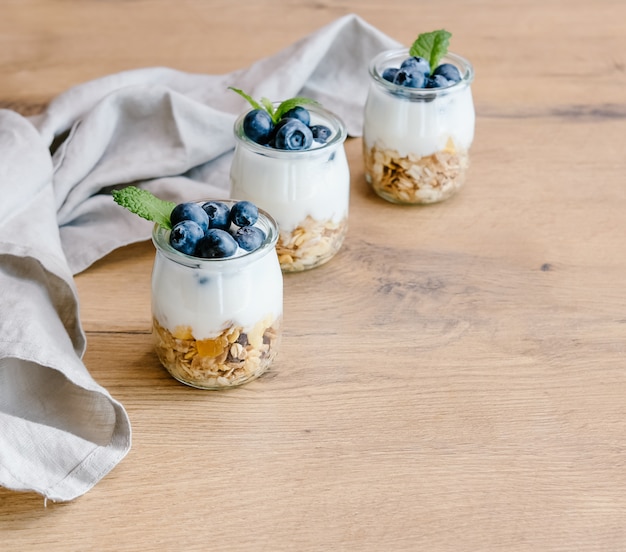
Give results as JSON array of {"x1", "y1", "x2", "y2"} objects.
[{"x1": 363, "y1": 144, "x2": 469, "y2": 204}]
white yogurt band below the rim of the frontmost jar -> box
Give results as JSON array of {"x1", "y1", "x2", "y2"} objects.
[{"x1": 152, "y1": 251, "x2": 283, "y2": 339}]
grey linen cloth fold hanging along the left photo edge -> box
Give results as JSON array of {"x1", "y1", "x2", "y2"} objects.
[{"x1": 0, "y1": 110, "x2": 131, "y2": 500}]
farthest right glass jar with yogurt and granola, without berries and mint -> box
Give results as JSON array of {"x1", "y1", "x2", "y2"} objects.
[{"x1": 363, "y1": 49, "x2": 475, "y2": 204}]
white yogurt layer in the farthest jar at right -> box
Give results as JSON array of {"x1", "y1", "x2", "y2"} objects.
[{"x1": 363, "y1": 83, "x2": 475, "y2": 157}]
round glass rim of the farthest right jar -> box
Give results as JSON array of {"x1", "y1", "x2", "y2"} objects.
[{"x1": 369, "y1": 48, "x2": 474, "y2": 100}]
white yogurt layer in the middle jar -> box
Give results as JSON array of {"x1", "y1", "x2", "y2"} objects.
[{"x1": 230, "y1": 110, "x2": 350, "y2": 231}]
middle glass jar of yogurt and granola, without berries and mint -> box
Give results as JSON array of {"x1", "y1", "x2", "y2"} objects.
[{"x1": 230, "y1": 105, "x2": 350, "y2": 272}]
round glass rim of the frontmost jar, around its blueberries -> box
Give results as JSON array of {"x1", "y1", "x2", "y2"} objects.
[{"x1": 152, "y1": 198, "x2": 279, "y2": 268}]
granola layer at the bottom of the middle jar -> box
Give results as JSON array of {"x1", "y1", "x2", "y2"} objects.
[{"x1": 276, "y1": 215, "x2": 348, "y2": 272}]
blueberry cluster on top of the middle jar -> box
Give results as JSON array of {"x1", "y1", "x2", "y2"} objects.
[{"x1": 243, "y1": 106, "x2": 332, "y2": 151}]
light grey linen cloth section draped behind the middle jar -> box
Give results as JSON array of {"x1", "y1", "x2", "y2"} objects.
[{"x1": 37, "y1": 14, "x2": 399, "y2": 274}]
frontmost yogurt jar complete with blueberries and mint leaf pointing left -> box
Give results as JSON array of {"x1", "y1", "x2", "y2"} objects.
[{"x1": 113, "y1": 186, "x2": 283, "y2": 390}]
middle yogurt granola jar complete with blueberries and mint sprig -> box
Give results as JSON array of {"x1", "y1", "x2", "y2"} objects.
[{"x1": 230, "y1": 88, "x2": 350, "y2": 273}]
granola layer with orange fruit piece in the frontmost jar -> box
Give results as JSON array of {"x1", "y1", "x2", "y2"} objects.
[{"x1": 152, "y1": 317, "x2": 281, "y2": 389}]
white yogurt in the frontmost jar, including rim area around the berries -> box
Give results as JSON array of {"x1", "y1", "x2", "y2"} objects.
[{"x1": 152, "y1": 208, "x2": 283, "y2": 340}]
